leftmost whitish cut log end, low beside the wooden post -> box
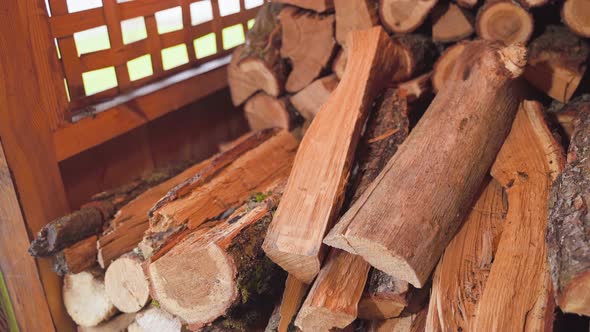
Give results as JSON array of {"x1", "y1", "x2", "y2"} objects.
[{"x1": 63, "y1": 269, "x2": 117, "y2": 326}]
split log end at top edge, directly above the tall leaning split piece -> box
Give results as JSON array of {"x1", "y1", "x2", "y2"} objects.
[{"x1": 334, "y1": 0, "x2": 379, "y2": 47}]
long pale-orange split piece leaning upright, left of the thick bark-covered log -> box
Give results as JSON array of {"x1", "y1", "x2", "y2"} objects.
[{"x1": 264, "y1": 27, "x2": 400, "y2": 283}]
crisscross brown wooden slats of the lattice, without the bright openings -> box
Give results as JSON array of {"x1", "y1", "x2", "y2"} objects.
[{"x1": 48, "y1": 0, "x2": 259, "y2": 112}]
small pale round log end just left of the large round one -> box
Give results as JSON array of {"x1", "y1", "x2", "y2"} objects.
[{"x1": 104, "y1": 253, "x2": 150, "y2": 313}]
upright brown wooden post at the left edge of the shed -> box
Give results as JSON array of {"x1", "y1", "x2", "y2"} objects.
[{"x1": 0, "y1": 0, "x2": 74, "y2": 331}]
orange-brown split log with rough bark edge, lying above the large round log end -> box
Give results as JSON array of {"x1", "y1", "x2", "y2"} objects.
[{"x1": 146, "y1": 131, "x2": 298, "y2": 258}]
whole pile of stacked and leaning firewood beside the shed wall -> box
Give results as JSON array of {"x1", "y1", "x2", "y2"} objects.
[{"x1": 30, "y1": 0, "x2": 590, "y2": 332}]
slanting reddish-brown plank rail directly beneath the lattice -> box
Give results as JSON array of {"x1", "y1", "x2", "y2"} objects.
[{"x1": 53, "y1": 66, "x2": 227, "y2": 161}]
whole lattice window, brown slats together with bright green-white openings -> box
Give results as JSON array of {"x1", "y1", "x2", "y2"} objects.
[{"x1": 47, "y1": 0, "x2": 264, "y2": 111}]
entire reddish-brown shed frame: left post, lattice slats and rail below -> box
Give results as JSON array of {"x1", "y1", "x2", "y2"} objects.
[{"x1": 0, "y1": 0, "x2": 258, "y2": 331}]
